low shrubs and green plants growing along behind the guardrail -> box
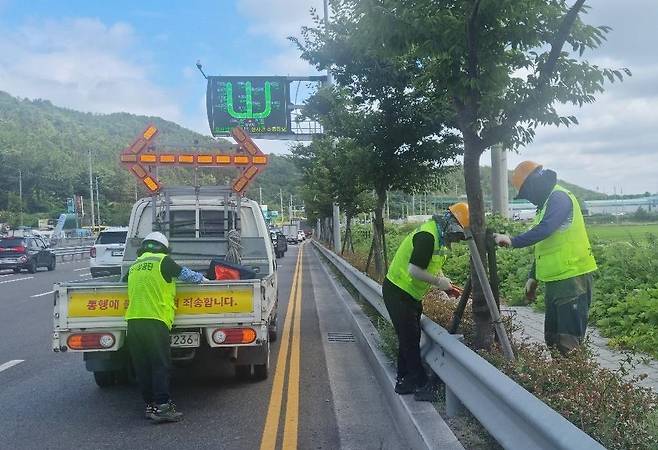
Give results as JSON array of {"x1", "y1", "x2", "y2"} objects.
[{"x1": 328, "y1": 222, "x2": 658, "y2": 449}]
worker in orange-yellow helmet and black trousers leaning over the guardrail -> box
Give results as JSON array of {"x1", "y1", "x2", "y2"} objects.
[{"x1": 382, "y1": 202, "x2": 469, "y2": 401}]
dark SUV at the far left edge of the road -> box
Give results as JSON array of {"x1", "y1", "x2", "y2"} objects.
[{"x1": 0, "y1": 236, "x2": 56, "y2": 273}]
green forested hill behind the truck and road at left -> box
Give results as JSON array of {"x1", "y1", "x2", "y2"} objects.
[{"x1": 0, "y1": 92, "x2": 296, "y2": 225}]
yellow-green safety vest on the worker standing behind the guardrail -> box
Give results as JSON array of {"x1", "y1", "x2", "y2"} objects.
[{"x1": 535, "y1": 184, "x2": 596, "y2": 281}]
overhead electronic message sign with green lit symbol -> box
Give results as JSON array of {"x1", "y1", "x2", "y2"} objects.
[{"x1": 206, "y1": 76, "x2": 290, "y2": 136}]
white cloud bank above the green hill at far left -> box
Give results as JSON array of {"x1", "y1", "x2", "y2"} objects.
[{"x1": 0, "y1": 18, "x2": 181, "y2": 120}]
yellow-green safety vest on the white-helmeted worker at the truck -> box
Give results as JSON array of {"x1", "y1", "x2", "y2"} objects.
[{"x1": 125, "y1": 252, "x2": 176, "y2": 329}]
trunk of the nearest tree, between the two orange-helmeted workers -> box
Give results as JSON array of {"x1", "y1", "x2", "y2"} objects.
[{"x1": 464, "y1": 143, "x2": 493, "y2": 349}]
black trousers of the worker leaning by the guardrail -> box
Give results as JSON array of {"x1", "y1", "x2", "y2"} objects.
[{"x1": 382, "y1": 278, "x2": 427, "y2": 385}]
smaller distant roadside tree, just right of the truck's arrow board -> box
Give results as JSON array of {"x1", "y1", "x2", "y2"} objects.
[{"x1": 292, "y1": 136, "x2": 374, "y2": 253}]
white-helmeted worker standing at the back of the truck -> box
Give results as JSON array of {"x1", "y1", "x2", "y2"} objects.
[{"x1": 124, "y1": 231, "x2": 207, "y2": 423}]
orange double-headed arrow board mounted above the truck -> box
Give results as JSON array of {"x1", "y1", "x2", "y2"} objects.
[{"x1": 121, "y1": 125, "x2": 267, "y2": 193}]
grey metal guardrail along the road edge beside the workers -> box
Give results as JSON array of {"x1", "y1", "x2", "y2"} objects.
[{"x1": 313, "y1": 241, "x2": 604, "y2": 450}]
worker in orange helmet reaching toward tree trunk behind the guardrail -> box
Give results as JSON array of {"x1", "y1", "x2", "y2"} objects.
[{"x1": 494, "y1": 161, "x2": 597, "y2": 355}]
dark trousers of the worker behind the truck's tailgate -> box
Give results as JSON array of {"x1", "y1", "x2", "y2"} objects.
[{"x1": 126, "y1": 319, "x2": 171, "y2": 405}]
